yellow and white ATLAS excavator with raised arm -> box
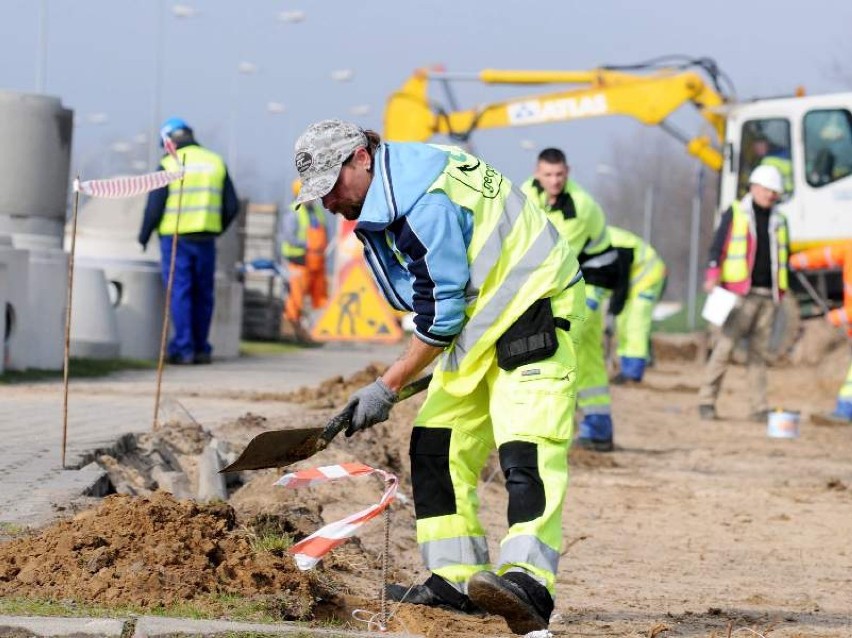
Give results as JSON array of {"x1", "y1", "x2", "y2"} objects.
[{"x1": 384, "y1": 56, "x2": 852, "y2": 268}]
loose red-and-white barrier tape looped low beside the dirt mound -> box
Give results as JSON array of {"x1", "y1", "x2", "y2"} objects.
[{"x1": 275, "y1": 463, "x2": 399, "y2": 571}]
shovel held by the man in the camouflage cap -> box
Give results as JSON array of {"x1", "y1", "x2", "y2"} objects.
[{"x1": 221, "y1": 374, "x2": 432, "y2": 472}]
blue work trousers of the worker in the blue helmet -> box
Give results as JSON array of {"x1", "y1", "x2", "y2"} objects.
[{"x1": 160, "y1": 235, "x2": 216, "y2": 361}]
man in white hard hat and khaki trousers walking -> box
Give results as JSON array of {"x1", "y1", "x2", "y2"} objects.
[{"x1": 699, "y1": 164, "x2": 790, "y2": 421}]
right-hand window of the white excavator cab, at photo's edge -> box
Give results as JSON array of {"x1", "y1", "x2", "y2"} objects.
[{"x1": 805, "y1": 109, "x2": 852, "y2": 188}]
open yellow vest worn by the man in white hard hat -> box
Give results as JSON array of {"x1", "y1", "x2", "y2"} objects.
[{"x1": 721, "y1": 202, "x2": 789, "y2": 298}]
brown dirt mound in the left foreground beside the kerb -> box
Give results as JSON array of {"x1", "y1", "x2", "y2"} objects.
[{"x1": 0, "y1": 492, "x2": 335, "y2": 619}]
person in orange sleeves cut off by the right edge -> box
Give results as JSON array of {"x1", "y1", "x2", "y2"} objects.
[{"x1": 790, "y1": 242, "x2": 852, "y2": 423}]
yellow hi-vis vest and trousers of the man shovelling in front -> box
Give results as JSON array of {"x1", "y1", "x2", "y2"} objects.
[{"x1": 410, "y1": 148, "x2": 585, "y2": 592}]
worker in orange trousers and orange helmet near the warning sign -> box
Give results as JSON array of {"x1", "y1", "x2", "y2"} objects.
[{"x1": 281, "y1": 180, "x2": 328, "y2": 340}]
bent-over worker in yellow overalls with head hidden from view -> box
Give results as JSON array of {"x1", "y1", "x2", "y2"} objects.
[{"x1": 609, "y1": 226, "x2": 666, "y2": 384}]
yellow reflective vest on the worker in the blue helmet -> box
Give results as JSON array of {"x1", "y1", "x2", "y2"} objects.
[{"x1": 158, "y1": 145, "x2": 226, "y2": 235}]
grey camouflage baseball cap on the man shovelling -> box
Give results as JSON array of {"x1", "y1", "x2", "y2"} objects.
[{"x1": 295, "y1": 120, "x2": 368, "y2": 204}]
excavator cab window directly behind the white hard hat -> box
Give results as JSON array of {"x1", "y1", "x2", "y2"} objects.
[{"x1": 737, "y1": 118, "x2": 793, "y2": 197}]
